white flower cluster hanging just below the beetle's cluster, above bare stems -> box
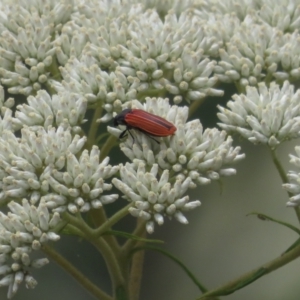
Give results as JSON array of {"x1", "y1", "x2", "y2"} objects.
[{"x1": 112, "y1": 160, "x2": 200, "y2": 233}]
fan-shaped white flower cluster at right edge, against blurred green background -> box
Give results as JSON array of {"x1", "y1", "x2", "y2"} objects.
[{"x1": 218, "y1": 81, "x2": 300, "y2": 148}]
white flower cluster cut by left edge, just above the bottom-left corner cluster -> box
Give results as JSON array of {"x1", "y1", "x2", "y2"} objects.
[{"x1": 0, "y1": 125, "x2": 86, "y2": 203}]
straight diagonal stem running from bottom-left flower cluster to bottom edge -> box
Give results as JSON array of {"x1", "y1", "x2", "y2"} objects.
[{"x1": 42, "y1": 245, "x2": 113, "y2": 300}]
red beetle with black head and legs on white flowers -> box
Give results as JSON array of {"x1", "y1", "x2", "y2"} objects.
[{"x1": 114, "y1": 108, "x2": 177, "y2": 144}]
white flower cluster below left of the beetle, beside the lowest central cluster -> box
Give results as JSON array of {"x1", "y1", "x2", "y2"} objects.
[{"x1": 41, "y1": 146, "x2": 119, "y2": 213}]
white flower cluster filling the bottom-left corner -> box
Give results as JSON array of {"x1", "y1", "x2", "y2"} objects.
[{"x1": 0, "y1": 199, "x2": 61, "y2": 299}]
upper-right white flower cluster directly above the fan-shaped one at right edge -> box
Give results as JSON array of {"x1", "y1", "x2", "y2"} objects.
[{"x1": 215, "y1": 17, "x2": 283, "y2": 86}]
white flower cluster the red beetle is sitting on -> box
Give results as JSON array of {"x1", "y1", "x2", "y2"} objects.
[{"x1": 108, "y1": 98, "x2": 244, "y2": 187}]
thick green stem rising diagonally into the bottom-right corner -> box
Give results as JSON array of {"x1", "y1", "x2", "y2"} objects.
[{"x1": 198, "y1": 245, "x2": 300, "y2": 300}]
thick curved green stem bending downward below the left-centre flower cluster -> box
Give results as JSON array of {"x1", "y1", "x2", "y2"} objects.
[{"x1": 63, "y1": 213, "x2": 124, "y2": 291}]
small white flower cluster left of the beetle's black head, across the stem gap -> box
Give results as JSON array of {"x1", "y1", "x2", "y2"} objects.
[{"x1": 12, "y1": 90, "x2": 87, "y2": 132}]
